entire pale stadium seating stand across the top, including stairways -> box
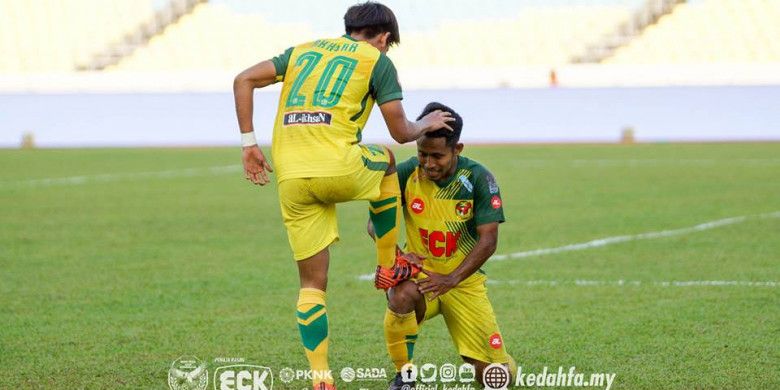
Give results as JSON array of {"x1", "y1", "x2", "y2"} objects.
[{"x1": 0, "y1": 0, "x2": 780, "y2": 84}]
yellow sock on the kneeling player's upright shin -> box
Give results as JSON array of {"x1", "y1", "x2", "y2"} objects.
[{"x1": 385, "y1": 308, "x2": 417, "y2": 372}]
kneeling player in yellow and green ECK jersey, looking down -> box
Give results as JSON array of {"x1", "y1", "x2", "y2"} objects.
[{"x1": 369, "y1": 103, "x2": 516, "y2": 390}]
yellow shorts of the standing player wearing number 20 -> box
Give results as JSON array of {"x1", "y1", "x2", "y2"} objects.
[{"x1": 279, "y1": 145, "x2": 390, "y2": 260}]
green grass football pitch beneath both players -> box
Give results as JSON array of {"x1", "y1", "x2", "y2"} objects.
[{"x1": 0, "y1": 143, "x2": 780, "y2": 389}]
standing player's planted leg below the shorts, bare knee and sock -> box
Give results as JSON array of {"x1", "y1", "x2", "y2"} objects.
[{"x1": 297, "y1": 248, "x2": 333, "y2": 390}]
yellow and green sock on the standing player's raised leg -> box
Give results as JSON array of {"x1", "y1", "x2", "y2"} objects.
[{"x1": 369, "y1": 173, "x2": 403, "y2": 268}]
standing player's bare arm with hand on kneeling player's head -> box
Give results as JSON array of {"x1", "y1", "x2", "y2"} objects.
[{"x1": 379, "y1": 100, "x2": 455, "y2": 144}]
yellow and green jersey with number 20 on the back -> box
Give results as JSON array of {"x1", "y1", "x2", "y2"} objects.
[{"x1": 271, "y1": 35, "x2": 402, "y2": 182}]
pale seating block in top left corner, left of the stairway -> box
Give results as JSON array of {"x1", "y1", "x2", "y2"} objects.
[{"x1": 0, "y1": 0, "x2": 154, "y2": 74}]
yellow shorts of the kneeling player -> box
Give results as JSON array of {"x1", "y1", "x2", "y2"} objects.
[{"x1": 423, "y1": 274, "x2": 514, "y2": 363}]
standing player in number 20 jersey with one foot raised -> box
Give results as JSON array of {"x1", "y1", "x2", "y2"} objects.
[{"x1": 233, "y1": 2, "x2": 452, "y2": 390}]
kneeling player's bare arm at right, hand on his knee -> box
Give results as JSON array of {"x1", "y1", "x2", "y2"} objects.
[{"x1": 418, "y1": 222, "x2": 498, "y2": 299}]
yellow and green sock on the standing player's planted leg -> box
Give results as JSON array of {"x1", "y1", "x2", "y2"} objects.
[{"x1": 297, "y1": 288, "x2": 333, "y2": 384}]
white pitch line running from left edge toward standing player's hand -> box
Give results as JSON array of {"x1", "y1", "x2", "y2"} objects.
[{"x1": 0, "y1": 164, "x2": 241, "y2": 188}]
